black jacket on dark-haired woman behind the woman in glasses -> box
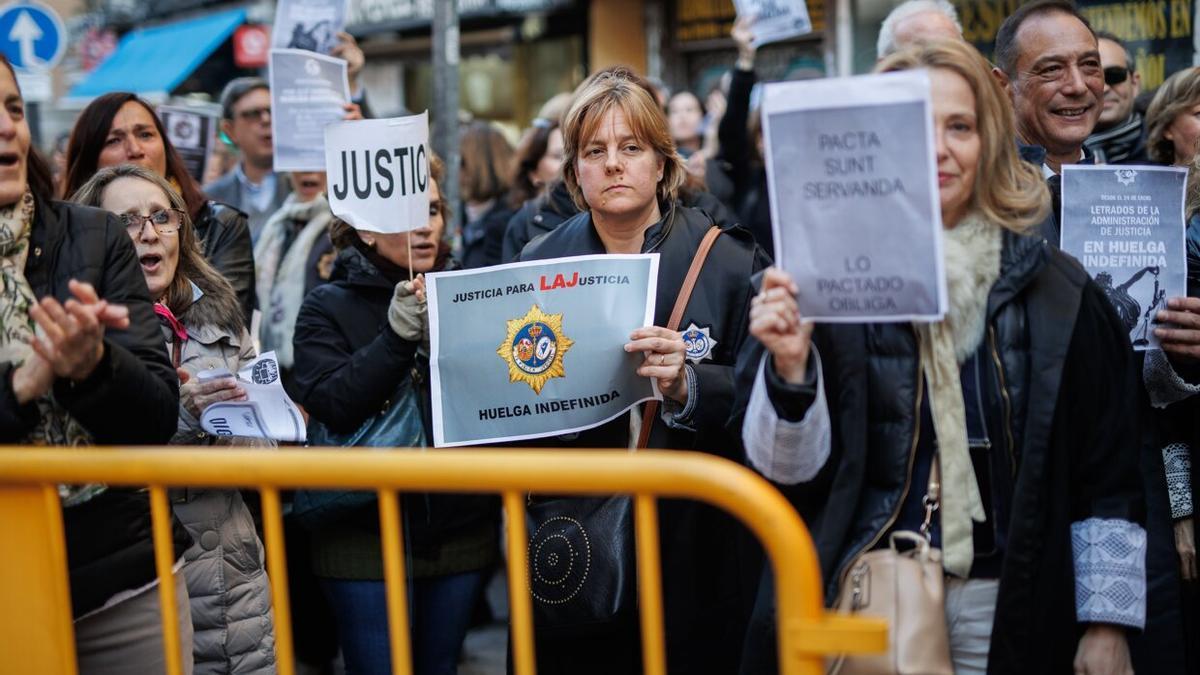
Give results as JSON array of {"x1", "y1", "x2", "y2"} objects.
[{"x1": 194, "y1": 198, "x2": 255, "y2": 325}]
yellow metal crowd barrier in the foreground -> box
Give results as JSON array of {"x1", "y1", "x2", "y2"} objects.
[{"x1": 0, "y1": 447, "x2": 887, "y2": 675}]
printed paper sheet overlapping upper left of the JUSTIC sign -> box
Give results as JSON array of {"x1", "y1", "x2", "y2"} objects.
[{"x1": 270, "y1": 49, "x2": 350, "y2": 171}]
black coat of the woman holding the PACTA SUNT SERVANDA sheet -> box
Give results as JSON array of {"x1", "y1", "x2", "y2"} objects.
[{"x1": 732, "y1": 227, "x2": 1144, "y2": 674}]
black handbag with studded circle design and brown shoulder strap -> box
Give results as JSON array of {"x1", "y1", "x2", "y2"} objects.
[{"x1": 526, "y1": 227, "x2": 721, "y2": 633}]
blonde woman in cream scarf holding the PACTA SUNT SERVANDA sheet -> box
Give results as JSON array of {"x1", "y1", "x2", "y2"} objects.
[{"x1": 734, "y1": 42, "x2": 1146, "y2": 674}]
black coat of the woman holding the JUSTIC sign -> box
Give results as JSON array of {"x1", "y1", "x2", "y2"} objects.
[{"x1": 293, "y1": 243, "x2": 499, "y2": 558}]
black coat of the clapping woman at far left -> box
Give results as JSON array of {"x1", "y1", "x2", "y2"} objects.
[{"x1": 0, "y1": 199, "x2": 188, "y2": 616}]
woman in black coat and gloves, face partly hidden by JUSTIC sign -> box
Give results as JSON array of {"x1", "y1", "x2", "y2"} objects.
[{"x1": 293, "y1": 159, "x2": 498, "y2": 675}]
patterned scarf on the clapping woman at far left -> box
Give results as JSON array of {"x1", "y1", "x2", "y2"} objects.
[{"x1": 0, "y1": 191, "x2": 103, "y2": 506}]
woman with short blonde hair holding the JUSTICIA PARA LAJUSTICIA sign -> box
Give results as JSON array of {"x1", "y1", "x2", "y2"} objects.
[{"x1": 521, "y1": 67, "x2": 767, "y2": 674}]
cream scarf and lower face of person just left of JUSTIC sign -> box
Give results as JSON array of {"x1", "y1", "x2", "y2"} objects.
[{"x1": 254, "y1": 171, "x2": 336, "y2": 393}]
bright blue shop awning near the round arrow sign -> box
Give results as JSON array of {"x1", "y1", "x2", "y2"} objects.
[{"x1": 67, "y1": 10, "x2": 246, "y2": 98}]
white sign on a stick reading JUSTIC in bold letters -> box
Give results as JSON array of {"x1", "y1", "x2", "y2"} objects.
[{"x1": 322, "y1": 113, "x2": 430, "y2": 233}]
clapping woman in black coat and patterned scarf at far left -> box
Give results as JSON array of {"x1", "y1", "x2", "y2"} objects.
[{"x1": 0, "y1": 56, "x2": 192, "y2": 675}]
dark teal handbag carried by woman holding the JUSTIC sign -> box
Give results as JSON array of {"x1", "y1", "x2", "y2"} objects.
[{"x1": 292, "y1": 376, "x2": 427, "y2": 528}]
